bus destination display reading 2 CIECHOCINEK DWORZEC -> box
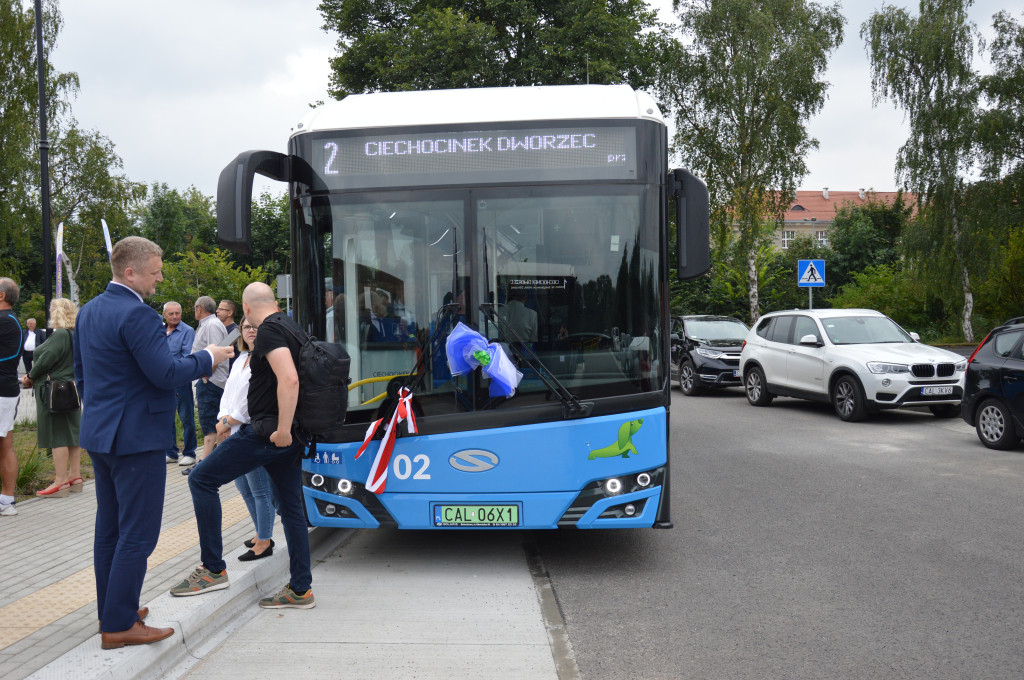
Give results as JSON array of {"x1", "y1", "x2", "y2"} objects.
[{"x1": 312, "y1": 126, "x2": 637, "y2": 188}]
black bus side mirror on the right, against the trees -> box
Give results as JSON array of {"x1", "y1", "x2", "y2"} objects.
[{"x1": 669, "y1": 170, "x2": 711, "y2": 281}]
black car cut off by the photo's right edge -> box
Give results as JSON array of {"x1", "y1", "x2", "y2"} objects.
[{"x1": 961, "y1": 316, "x2": 1024, "y2": 450}]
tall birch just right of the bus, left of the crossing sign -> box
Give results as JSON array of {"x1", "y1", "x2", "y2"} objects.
[{"x1": 658, "y1": 0, "x2": 844, "y2": 321}]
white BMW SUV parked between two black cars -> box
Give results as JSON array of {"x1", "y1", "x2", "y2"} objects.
[{"x1": 739, "y1": 309, "x2": 967, "y2": 421}]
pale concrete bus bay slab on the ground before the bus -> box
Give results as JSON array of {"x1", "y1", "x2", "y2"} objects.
[{"x1": 185, "y1": 529, "x2": 579, "y2": 680}]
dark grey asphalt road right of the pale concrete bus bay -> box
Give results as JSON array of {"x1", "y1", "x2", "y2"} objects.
[{"x1": 534, "y1": 389, "x2": 1024, "y2": 680}]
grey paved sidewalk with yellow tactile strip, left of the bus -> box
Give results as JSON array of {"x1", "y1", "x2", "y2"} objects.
[{"x1": 0, "y1": 458, "x2": 342, "y2": 680}]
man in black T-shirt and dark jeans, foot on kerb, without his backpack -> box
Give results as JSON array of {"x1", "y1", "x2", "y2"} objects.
[{"x1": 171, "y1": 283, "x2": 315, "y2": 609}]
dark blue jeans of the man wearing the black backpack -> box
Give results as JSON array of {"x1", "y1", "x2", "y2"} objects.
[{"x1": 188, "y1": 425, "x2": 312, "y2": 594}]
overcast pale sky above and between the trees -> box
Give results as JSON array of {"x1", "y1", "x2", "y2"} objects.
[{"x1": 44, "y1": 0, "x2": 1024, "y2": 196}]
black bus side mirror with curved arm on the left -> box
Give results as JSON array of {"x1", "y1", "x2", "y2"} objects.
[{"x1": 217, "y1": 152, "x2": 292, "y2": 255}]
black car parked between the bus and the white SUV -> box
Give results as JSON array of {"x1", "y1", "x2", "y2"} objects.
[{"x1": 672, "y1": 315, "x2": 748, "y2": 396}]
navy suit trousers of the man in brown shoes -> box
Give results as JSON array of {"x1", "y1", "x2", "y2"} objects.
[{"x1": 89, "y1": 451, "x2": 167, "y2": 633}]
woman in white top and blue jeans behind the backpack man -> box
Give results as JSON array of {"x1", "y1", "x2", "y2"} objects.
[{"x1": 217, "y1": 316, "x2": 278, "y2": 562}]
